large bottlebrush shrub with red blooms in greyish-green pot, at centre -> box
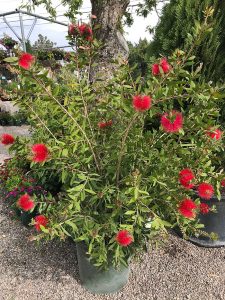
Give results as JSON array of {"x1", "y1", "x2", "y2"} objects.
[{"x1": 4, "y1": 16, "x2": 223, "y2": 293}]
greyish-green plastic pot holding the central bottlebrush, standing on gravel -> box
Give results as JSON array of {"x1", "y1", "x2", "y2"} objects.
[{"x1": 76, "y1": 243, "x2": 129, "y2": 294}]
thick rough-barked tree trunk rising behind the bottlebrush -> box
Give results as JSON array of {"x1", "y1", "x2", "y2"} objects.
[{"x1": 91, "y1": 0, "x2": 130, "y2": 80}]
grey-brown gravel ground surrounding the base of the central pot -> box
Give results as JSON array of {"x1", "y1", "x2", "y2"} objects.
[{"x1": 0, "y1": 125, "x2": 225, "y2": 300}]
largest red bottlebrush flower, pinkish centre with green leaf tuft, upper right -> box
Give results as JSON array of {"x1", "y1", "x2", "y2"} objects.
[{"x1": 161, "y1": 110, "x2": 183, "y2": 132}]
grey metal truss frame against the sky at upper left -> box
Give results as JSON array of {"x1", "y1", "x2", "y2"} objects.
[{"x1": 0, "y1": 9, "x2": 68, "y2": 52}]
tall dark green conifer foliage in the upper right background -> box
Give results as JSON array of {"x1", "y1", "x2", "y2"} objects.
[{"x1": 144, "y1": 0, "x2": 225, "y2": 81}]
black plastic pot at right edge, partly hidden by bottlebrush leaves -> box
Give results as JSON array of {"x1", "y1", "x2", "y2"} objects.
[{"x1": 190, "y1": 195, "x2": 225, "y2": 247}]
